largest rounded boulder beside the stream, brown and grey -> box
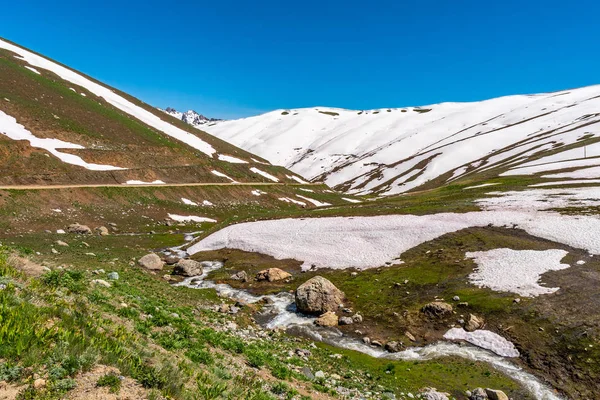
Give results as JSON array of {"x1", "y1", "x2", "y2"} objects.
[{"x1": 296, "y1": 276, "x2": 345, "y2": 315}]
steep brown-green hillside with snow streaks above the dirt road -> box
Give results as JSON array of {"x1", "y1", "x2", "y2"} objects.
[{"x1": 0, "y1": 39, "x2": 302, "y2": 184}]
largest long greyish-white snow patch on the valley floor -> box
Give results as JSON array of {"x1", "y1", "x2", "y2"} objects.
[{"x1": 188, "y1": 211, "x2": 600, "y2": 269}]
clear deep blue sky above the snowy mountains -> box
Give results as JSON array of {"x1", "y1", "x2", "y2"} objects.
[{"x1": 0, "y1": 0, "x2": 600, "y2": 118}]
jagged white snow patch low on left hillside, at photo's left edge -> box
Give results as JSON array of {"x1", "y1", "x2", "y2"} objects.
[{"x1": 0, "y1": 110, "x2": 125, "y2": 171}]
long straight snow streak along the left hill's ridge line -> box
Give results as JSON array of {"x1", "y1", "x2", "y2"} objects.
[{"x1": 0, "y1": 39, "x2": 216, "y2": 156}]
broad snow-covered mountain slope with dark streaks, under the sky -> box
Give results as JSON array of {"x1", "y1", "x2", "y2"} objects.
[{"x1": 203, "y1": 86, "x2": 600, "y2": 195}]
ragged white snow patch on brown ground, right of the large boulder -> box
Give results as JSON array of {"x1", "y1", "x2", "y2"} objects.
[{"x1": 466, "y1": 249, "x2": 570, "y2": 297}]
